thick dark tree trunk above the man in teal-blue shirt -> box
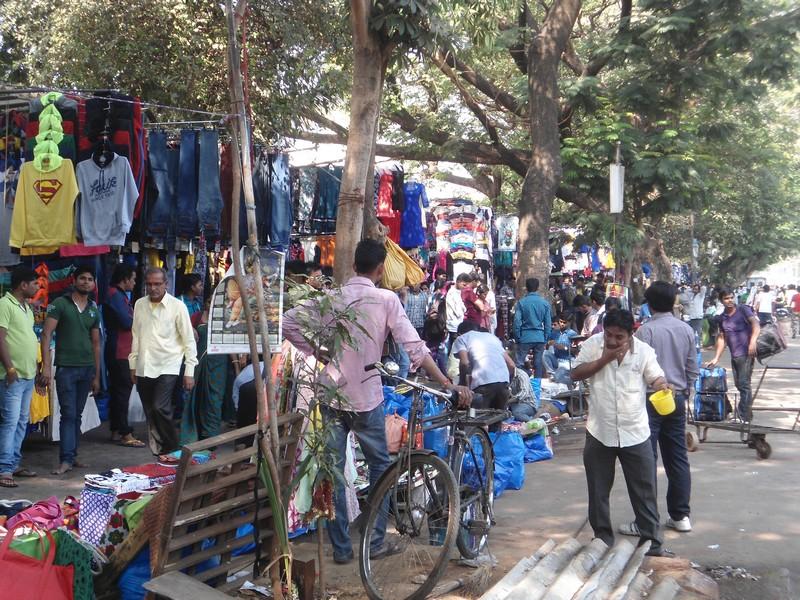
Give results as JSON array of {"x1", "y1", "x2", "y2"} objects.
[{"x1": 517, "y1": 0, "x2": 581, "y2": 294}]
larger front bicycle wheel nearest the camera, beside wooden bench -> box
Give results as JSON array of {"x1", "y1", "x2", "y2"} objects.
[{"x1": 359, "y1": 454, "x2": 459, "y2": 600}]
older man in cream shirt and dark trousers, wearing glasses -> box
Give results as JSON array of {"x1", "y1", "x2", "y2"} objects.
[{"x1": 128, "y1": 268, "x2": 197, "y2": 455}]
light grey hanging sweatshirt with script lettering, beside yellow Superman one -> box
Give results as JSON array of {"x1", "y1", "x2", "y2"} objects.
[{"x1": 76, "y1": 154, "x2": 139, "y2": 246}]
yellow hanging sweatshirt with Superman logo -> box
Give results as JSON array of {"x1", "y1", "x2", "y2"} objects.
[{"x1": 10, "y1": 159, "x2": 78, "y2": 254}]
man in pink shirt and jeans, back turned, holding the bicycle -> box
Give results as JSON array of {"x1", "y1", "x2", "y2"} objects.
[{"x1": 283, "y1": 240, "x2": 472, "y2": 564}]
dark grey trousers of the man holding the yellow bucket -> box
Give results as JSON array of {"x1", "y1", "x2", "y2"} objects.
[{"x1": 583, "y1": 432, "x2": 662, "y2": 551}]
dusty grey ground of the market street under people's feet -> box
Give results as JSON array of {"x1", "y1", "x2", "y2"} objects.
[{"x1": 0, "y1": 341, "x2": 800, "y2": 600}]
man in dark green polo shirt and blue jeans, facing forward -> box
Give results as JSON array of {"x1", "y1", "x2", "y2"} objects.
[{"x1": 41, "y1": 266, "x2": 100, "y2": 475}]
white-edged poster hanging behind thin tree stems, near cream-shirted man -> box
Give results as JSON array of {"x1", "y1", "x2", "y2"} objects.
[{"x1": 208, "y1": 248, "x2": 284, "y2": 354}]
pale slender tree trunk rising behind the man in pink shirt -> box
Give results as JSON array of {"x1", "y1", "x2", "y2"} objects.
[{"x1": 333, "y1": 0, "x2": 390, "y2": 283}]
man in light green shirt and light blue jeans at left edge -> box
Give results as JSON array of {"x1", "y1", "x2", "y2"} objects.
[{"x1": 0, "y1": 267, "x2": 39, "y2": 487}]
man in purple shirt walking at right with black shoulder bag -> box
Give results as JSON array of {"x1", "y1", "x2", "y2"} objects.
[{"x1": 706, "y1": 288, "x2": 761, "y2": 421}]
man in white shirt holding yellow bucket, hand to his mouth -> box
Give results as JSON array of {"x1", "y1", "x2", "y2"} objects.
[{"x1": 571, "y1": 310, "x2": 668, "y2": 556}]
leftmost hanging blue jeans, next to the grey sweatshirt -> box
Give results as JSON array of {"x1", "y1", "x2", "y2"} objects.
[{"x1": 147, "y1": 131, "x2": 179, "y2": 237}]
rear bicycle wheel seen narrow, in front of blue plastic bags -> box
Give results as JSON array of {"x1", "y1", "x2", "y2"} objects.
[{"x1": 453, "y1": 427, "x2": 494, "y2": 558}]
